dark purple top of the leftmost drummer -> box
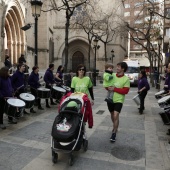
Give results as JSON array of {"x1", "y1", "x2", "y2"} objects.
[{"x1": 0, "y1": 77, "x2": 13, "y2": 98}]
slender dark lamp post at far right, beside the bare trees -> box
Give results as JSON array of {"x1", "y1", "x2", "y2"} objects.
[{"x1": 157, "y1": 35, "x2": 163, "y2": 90}]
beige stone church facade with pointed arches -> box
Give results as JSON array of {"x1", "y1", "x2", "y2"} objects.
[{"x1": 0, "y1": 0, "x2": 127, "y2": 71}]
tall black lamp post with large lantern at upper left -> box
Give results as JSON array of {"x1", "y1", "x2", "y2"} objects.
[{"x1": 31, "y1": 0, "x2": 43, "y2": 66}]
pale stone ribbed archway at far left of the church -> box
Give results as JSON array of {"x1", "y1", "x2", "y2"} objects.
[{"x1": 4, "y1": 1, "x2": 25, "y2": 63}]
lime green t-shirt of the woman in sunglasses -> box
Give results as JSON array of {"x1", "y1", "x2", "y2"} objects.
[{"x1": 71, "y1": 76, "x2": 93, "y2": 99}]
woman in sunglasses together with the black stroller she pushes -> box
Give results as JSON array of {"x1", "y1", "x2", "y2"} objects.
[{"x1": 51, "y1": 64, "x2": 94, "y2": 165}]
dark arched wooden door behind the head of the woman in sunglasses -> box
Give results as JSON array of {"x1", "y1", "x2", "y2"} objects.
[{"x1": 72, "y1": 51, "x2": 84, "y2": 72}]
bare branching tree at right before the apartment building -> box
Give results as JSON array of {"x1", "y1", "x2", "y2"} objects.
[{"x1": 123, "y1": 0, "x2": 163, "y2": 86}]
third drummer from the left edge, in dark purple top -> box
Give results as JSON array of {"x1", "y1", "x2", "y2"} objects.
[{"x1": 28, "y1": 66, "x2": 44, "y2": 113}]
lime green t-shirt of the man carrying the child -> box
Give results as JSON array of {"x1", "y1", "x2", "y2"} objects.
[{"x1": 113, "y1": 73, "x2": 130, "y2": 103}]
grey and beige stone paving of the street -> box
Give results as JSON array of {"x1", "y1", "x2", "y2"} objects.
[{"x1": 0, "y1": 84, "x2": 170, "y2": 170}]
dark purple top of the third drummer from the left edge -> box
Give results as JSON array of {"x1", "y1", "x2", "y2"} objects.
[{"x1": 28, "y1": 71, "x2": 41, "y2": 89}]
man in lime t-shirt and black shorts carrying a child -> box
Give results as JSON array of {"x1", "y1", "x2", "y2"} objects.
[{"x1": 107, "y1": 62, "x2": 130, "y2": 142}]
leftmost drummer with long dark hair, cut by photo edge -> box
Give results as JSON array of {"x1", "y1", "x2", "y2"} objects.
[{"x1": 0, "y1": 67, "x2": 17, "y2": 126}]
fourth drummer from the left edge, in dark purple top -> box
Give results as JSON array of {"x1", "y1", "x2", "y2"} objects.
[{"x1": 44, "y1": 64, "x2": 56, "y2": 108}]
